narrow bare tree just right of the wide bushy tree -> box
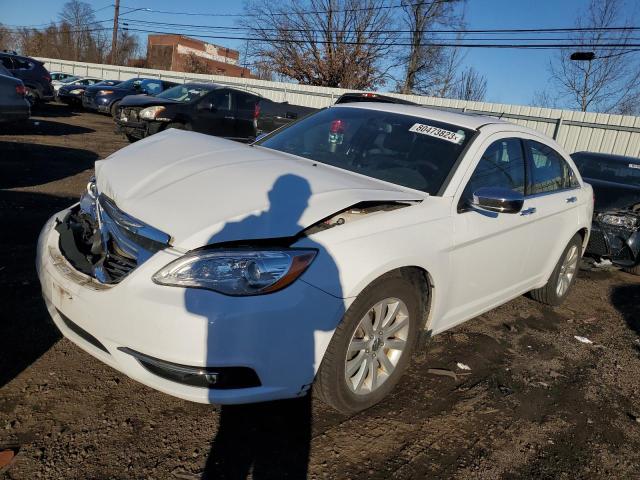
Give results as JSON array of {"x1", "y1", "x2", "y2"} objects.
[{"x1": 399, "y1": 0, "x2": 464, "y2": 96}]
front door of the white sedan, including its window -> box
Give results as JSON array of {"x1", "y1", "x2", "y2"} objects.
[{"x1": 438, "y1": 133, "x2": 536, "y2": 328}]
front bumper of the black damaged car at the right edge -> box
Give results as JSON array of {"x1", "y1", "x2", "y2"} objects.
[{"x1": 585, "y1": 219, "x2": 640, "y2": 268}]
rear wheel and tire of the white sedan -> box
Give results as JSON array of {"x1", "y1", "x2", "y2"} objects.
[{"x1": 530, "y1": 234, "x2": 582, "y2": 306}]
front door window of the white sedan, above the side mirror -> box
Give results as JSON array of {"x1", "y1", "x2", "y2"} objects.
[{"x1": 458, "y1": 138, "x2": 526, "y2": 210}]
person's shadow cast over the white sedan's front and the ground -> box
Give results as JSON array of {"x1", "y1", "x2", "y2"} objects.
[{"x1": 191, "y1": 174, "x2": 344, "y2": 480}]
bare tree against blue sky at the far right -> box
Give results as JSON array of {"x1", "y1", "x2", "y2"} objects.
[{"x1": 549, "y1": 0, "x2": 640, "y2": 112}]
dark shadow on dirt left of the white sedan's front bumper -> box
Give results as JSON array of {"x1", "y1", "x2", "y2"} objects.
[{"x1": 0, "y1": 190, "x2": 75, "y2": 387}]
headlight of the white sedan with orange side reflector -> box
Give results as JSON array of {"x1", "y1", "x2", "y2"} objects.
[{"x1": 153, "y1": 249, "x2": 316, "y2": 296}]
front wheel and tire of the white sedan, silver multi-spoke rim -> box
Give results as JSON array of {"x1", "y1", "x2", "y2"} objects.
[{"x1": 314, "y1": 270, "x2": 428, "y2": 414}]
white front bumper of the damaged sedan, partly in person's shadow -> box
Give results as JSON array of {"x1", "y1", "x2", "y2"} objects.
[{"x1": 36, "y1": 211, "x2": 346, "y2": 404}]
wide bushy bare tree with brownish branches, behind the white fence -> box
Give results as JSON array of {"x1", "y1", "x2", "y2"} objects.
[{"x1": 241, "y1": 0, "x2": 394, "y2": 89}]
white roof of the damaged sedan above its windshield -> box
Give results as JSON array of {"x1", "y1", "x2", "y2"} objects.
[{"x1": 330, "y1": 102, "x2": 512, "y2": 130}]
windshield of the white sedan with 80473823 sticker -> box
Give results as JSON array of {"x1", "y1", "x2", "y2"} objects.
[{"x1": 256, "y1": 107, "x2": 473, "y2": 195}]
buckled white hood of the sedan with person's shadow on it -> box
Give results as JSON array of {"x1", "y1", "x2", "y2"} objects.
[{"x1": 96, "y1": 129, "x2": 426, "y2": 250}]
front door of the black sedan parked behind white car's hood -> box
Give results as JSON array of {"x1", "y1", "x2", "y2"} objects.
[{"x1": 193, "y1": 89, "x2": 235, "y2": 137}]
